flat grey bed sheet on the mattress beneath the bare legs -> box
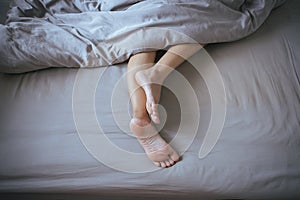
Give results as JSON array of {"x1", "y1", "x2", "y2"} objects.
[{"x1": 0, "y1": 0, "x2": 300, "y2": 199}]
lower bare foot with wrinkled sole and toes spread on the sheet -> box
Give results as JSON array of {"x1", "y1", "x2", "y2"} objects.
[{"x1": 130, "y1": 118, "x2": 179, "y2": 168}]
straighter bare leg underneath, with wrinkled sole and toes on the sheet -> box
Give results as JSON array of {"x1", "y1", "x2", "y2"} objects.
[{"x1": 127, "y1": 52, "x2": 179, "y2": 168}]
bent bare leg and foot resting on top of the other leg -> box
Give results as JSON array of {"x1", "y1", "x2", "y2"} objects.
[{"x1": 135, "y1": 44, "x2": 201, "y2": 124}]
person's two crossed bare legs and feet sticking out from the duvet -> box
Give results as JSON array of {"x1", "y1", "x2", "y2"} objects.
[{"x1": 127, "y1": 44, "x2": 201, "y2": 168}]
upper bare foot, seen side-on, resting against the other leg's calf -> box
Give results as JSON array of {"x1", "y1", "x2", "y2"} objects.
[{"x1": 135, "y1": 69, "x2": 163, "y2": 124}]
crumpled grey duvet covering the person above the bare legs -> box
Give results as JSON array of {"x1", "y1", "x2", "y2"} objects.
[{"x1": 0, "y1": 0, "x2": 284, "y2": 73}]
